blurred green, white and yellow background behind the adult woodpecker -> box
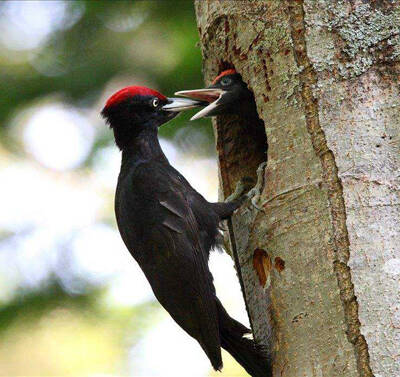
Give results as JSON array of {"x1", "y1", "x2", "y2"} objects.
[{"x1": 0, "y1": 0, "x2": 248, "y2": 377}]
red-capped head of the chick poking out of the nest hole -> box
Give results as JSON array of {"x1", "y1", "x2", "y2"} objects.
[{"x1": 175, "y1": 69, "x2": 254, "y2": 120}]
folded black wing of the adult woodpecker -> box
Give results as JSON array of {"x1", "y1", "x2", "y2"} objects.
[{"x1": 116, "y1": 163, "x2": 221, "y2": 368}]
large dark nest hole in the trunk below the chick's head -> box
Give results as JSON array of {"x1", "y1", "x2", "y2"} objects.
[{"x1": 212, "y1": 62, "x2": 268, "y2": 197}]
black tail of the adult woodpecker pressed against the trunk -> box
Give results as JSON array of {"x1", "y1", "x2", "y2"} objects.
[{"x1": 217, "y1": 299, "x2": 272, "y2": 377}]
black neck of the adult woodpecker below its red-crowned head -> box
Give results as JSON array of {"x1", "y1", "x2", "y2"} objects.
[{"x1": 122, "y1": 127, "x2": 168, "y2": 166}]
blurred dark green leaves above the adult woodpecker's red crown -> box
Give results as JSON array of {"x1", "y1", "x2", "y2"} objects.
[{"x1": 0, "y1": 0, "x2": 212, "y2": 153}]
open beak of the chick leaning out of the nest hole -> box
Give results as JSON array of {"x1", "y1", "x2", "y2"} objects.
[{"x1": 175, "y1": 88, "x2": 228, "y2": 120}]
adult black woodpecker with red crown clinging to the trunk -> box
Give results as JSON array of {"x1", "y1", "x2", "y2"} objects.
[{"x1": 101, "y1": 86, "x2": 270, "y2": 377}]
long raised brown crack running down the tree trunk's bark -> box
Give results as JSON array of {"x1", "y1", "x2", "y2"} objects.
[{"x1": 286, "y1": 0, "x2": 373, "y2": 377}]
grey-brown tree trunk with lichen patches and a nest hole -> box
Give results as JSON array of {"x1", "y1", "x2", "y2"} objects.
[{"x1": 195, "y1": 0, "x2": 400, "y2": 377}]
